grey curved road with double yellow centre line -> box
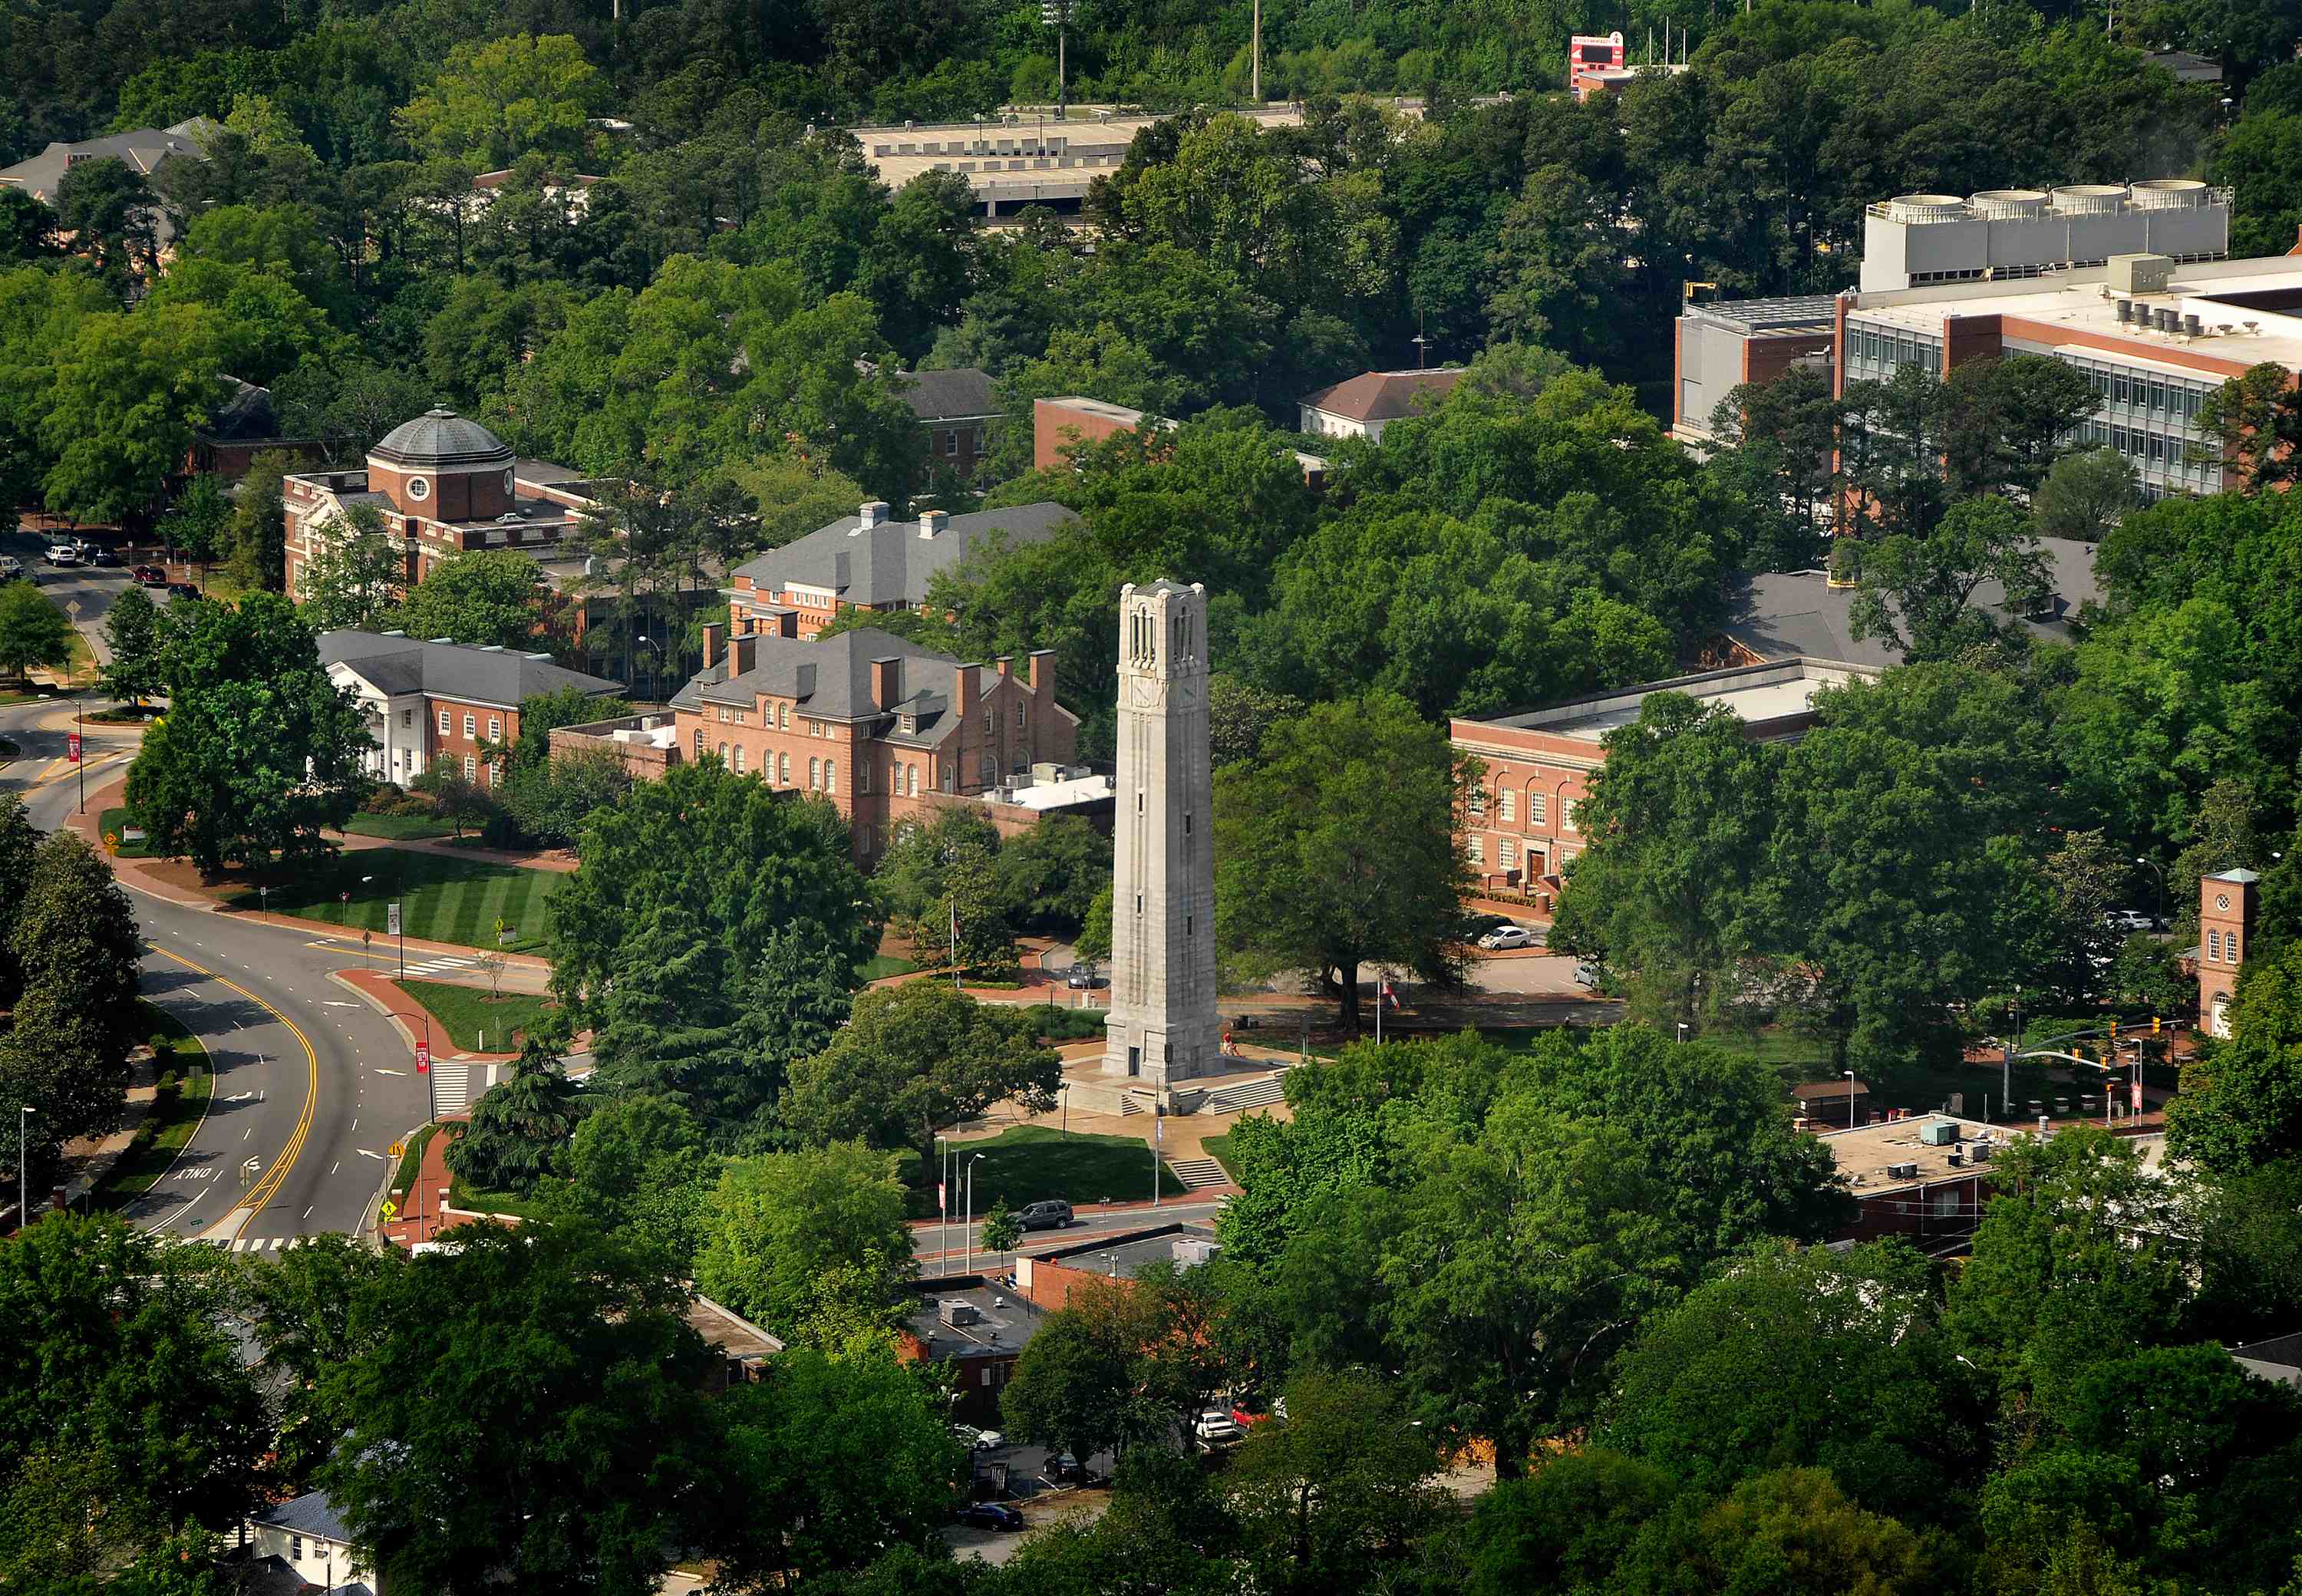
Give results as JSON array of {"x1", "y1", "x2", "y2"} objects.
[{"x1": 0, "y1": 536, "x2": 430, "y2": 1251}]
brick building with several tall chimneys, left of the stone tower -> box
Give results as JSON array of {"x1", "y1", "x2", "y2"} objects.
[{"x1": 670, "y1": 624, "x2": 1077, "y2": 864}]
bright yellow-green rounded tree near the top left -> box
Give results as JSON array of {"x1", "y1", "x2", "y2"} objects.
[{"x1": 396, "y1": 32, "x2": 605, "y2": 170}]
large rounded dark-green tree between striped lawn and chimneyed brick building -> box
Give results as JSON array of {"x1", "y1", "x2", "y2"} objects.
[{"x1": 552, "y1": 760, "x2": 879, "y2": 1023}]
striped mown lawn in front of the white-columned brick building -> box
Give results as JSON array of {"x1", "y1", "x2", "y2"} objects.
[{"x1": 233, "y1": 848, "x2": 559, "y2": 954}]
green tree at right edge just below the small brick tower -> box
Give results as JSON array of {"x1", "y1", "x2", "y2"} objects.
[{"x1": 2166, "y1": 942, "x2": 2302, "y2": 1175}]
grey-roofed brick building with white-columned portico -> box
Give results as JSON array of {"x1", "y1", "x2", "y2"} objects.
[{"x1": 320, "y1": 631, "x2": 622, "y2": 785}]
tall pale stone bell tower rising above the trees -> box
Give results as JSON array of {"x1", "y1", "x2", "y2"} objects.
[{"x1": 1103, "y1": 578, "x2": 1220, "y2": 1092}]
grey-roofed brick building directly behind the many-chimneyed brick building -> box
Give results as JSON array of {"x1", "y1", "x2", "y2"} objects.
[{"x1": 707, "y1": 500, "x2": 1077, "y2": 640}]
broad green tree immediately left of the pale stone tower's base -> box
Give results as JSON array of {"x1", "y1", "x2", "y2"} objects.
[{"x1": 783, "y1": 981, "x2": 1061, "y2": 1161}]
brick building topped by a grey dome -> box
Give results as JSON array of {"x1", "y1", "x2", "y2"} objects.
[{"x1": 281, "y1": 410, "x2": 594, "y2": 596}]
